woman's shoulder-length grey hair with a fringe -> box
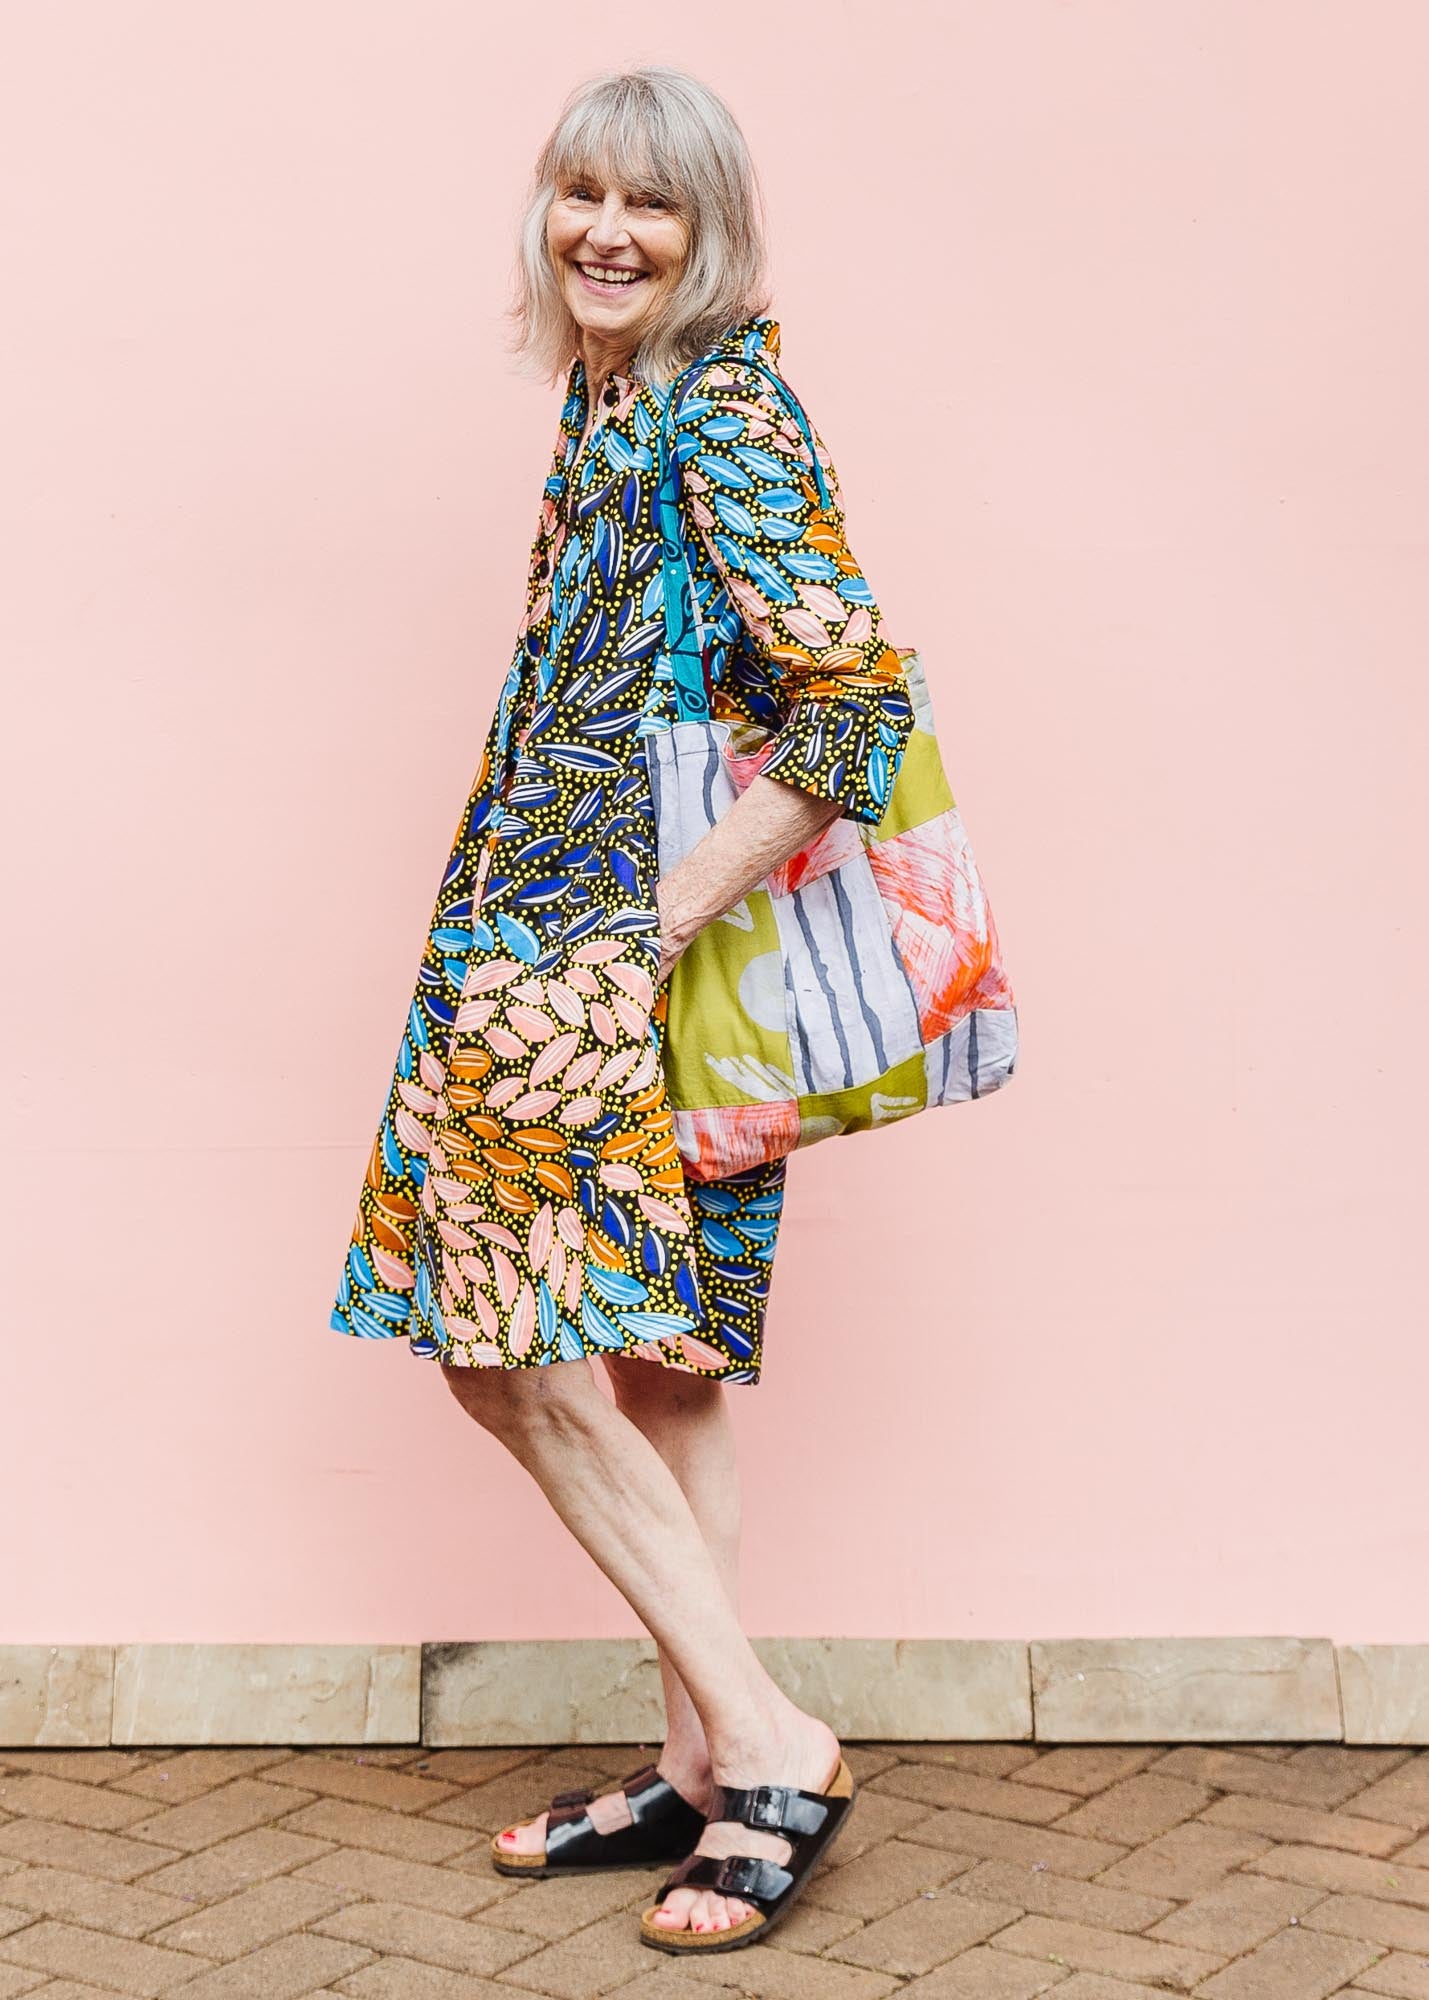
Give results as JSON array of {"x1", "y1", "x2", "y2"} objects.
[{"x1": 508, "y1": 64, "x2": 769, "y2": 382}]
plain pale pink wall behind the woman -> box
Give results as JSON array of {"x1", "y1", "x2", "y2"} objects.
[{"x1": 0, "y1": 0, "x2": 1429, "y2": 1642}]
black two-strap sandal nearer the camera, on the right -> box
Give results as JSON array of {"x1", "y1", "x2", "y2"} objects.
[{"x1": 640, "y1": 1756, "x2": 855, "y2": 1952}]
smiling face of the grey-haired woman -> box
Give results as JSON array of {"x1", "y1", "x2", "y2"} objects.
[{"x1": 546, "y1": 174, "x2": 688, "y2": 352}]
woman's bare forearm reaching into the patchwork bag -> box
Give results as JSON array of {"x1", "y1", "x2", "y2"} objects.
[{"x1": 654, "y1": 772, "x2": 843, "y2": 986}]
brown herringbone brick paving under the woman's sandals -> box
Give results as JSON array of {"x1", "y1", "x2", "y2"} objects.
[{"x1": 0, "y1": 1744, "x2": 1429, "y2": 2000}]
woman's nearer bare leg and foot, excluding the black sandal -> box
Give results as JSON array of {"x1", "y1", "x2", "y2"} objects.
[{"x1": 444, "y1": 1362, "x2": 839, "y2": 1930}]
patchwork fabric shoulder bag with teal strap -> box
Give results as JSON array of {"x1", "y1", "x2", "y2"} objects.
[{"x1": 646, "y1": 358, "x2": 1017, "y2": 1180}]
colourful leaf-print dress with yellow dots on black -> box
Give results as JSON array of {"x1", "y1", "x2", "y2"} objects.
[{"x1": 332, "y1": 314, "x2": 913, "y2": 1382}]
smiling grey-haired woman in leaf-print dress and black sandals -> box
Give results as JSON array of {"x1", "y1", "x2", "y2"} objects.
[{"x1": 334, "y1": 66, "x2": 913, "y2": 1952}]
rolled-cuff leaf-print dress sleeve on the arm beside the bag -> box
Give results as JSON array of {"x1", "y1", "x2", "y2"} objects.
[{"x1": 678, "y1": 358, "x2": 913, "y2": 824}]
